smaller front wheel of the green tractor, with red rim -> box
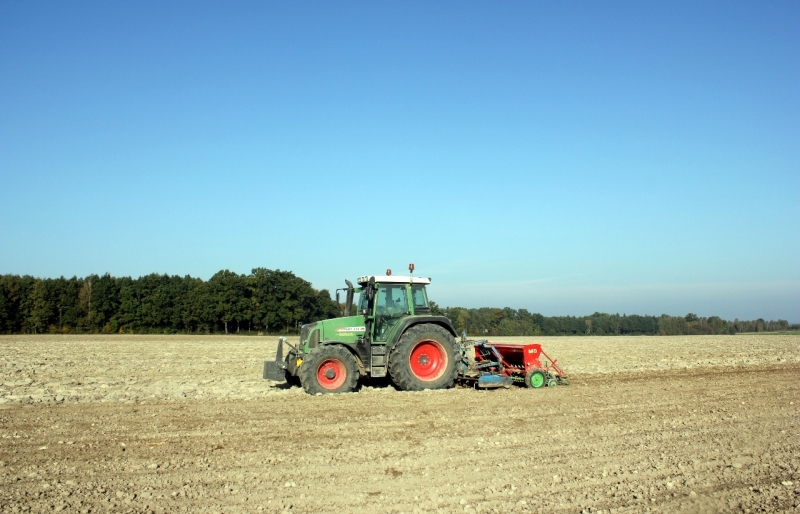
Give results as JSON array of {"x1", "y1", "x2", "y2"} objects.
[{"x1": 297, "y1": 345, "x2": 358, "y2": 394}]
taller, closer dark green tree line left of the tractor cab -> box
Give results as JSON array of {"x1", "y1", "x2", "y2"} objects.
[{"x1": 0, "y1": 268, "x2": 339, "y2": 334}]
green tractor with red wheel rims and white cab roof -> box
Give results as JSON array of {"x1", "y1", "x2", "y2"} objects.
[{"x1": 264, "y1": 264, "x2": 461, "y2": 394}]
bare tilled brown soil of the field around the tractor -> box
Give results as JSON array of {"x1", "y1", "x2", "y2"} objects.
[{"x1": 0, "y1": 335, "x2": 800, "y2": 512}]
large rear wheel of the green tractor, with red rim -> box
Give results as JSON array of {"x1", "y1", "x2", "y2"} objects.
[{"x1": 389, "y1": 323, "x2": 459, "y2": 391}]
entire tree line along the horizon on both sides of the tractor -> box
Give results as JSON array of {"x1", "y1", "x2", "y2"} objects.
[{"x1": 0, "y1": 268, "x2": 800, "y2": 337}]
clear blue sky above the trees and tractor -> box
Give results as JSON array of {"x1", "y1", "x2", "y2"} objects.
[{"x1": 0, "y1": 1, "x2": 800, "y2": 323}]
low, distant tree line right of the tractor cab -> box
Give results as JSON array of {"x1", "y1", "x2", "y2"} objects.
[{"x1": 432, "y1": 304, "x2": 800, "y2": 337}]
